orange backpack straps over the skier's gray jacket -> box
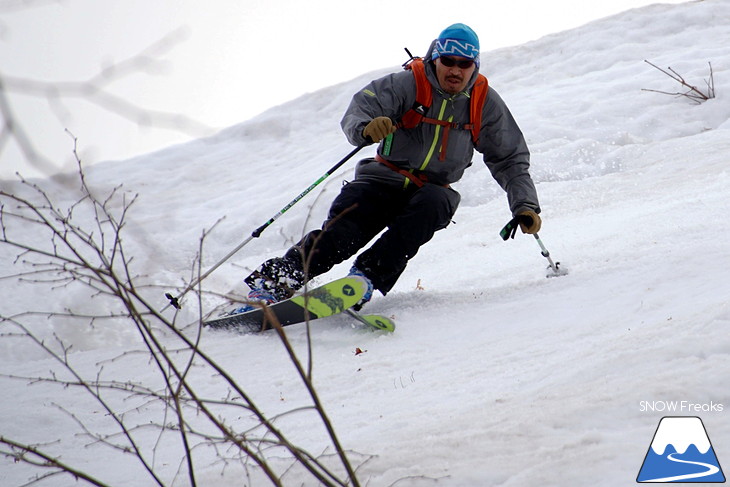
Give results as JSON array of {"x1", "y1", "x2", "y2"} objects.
[{"x1": 398, "y1": 57, "x2": 489, "y2": 151}]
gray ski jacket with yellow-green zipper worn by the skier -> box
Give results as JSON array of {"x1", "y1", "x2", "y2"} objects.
[{"x1": 341, "y1": 57, "x2": 540, "y2": 216}]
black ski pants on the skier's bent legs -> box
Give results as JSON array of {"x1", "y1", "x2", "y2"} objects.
[{"x1": 276, "y1": 179, "x2": 461, "y2": 294}]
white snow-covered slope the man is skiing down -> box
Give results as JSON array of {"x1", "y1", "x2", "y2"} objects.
[{"x1": 0, "y1": 0, "x2": 730, "y2": 487}]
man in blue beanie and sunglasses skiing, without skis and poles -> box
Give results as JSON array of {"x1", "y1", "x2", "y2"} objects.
[{"x1": 232, "y1": 24, "x2": 541, "y2": 313}]
